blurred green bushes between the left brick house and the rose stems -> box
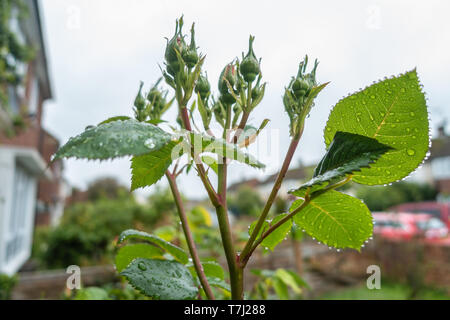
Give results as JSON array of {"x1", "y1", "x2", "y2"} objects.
[{"x1": 32, "y1": 178, "x2": 175, "y2": 269}]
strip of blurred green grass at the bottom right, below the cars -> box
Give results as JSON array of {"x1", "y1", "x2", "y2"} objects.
[{"x1": 318, "y1": 282, "x2": 450, "y2": 300}]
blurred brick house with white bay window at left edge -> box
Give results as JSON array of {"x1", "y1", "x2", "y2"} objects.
[{"x1": 0, "y1": 0, "x2": 65, "y2": 274}]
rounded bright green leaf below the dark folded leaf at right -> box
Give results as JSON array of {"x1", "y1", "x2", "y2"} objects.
[{"x1": 289, "y1": 190, "x2": 373, "y2": 251}]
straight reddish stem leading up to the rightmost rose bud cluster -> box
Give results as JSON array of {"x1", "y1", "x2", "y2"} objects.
[{"x1": 241, "y1": 130, "x2": 303, "y2": 261}]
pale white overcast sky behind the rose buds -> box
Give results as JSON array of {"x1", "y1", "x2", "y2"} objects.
[{"x1": 41, "y1": 0, "x2": 450, "y2": 197}]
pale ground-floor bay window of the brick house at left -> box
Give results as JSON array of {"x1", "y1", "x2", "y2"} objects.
[{"x1": 5, "y1": 164, "x2": 33, "y2": 263}]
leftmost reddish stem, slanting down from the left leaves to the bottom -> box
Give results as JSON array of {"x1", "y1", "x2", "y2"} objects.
[{"x1": 166, "y1": 170, "x2": 215, "y2": 300}]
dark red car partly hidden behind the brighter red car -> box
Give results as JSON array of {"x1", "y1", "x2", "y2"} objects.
[{"x1": 388, "y1": 201, "x2": 450, "y2": 229}]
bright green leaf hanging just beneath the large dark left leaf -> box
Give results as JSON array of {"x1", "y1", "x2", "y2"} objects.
[{"x1": 131, "y1": 141, "x2": 179, "y2": 191}]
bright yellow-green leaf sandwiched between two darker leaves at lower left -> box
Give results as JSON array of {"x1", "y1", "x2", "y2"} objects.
[{"x1": 115, "y1": 243, "x2": 163, "y2": 272}]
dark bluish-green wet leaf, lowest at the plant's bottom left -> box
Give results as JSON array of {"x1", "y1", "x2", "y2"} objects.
[{"x1": 120, "y1": 258, "x2": 198, "y2": 300}]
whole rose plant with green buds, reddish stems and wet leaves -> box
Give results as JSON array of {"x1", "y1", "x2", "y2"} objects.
[{"x1": 55, "y1": 17, "x2": 430, "y2": 299}]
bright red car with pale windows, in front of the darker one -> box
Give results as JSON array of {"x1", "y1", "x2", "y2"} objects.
[{"x1": 373, "y1": 212, "x2": 449, "y2": 242}]
